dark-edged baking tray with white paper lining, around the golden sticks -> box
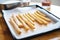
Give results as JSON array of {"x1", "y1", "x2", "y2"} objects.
[{"x1": 2, "y1": 5, "x2": 60, "y2": 39}]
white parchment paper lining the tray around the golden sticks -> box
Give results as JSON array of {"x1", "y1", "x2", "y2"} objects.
[{"x1": 3, "y1": 7, "x2": 60, "y2": 39}]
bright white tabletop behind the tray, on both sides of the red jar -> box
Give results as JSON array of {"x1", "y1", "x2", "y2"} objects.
[{"x1": 30, "y1": 2, "x2": 60, "y2": 18}]
